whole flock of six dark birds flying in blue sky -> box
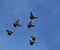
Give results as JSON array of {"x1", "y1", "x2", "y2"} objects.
[{"x1": 6, "y1": 12, "x2": 37, "y2": 45}]
